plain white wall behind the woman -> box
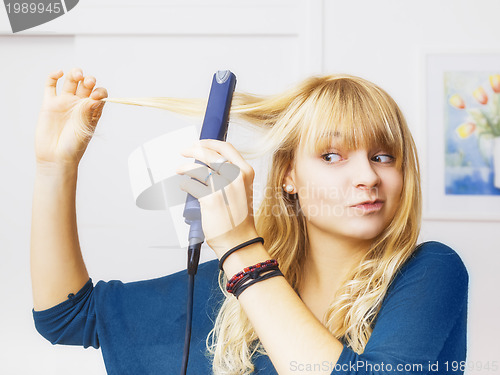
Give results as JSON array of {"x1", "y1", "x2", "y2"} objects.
[{"x1": 0, "y1": 0, "x2": 500, "y2": 374}]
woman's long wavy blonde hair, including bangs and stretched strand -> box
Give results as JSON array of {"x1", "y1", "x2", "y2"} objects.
[{"x1": 101, "y1": 75, "x2": 422, "y2": 374}]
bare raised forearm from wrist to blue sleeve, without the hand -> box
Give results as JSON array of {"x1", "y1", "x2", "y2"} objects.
[{"x1": 31, "y1": 166, "x2": 89, "y2": 311}]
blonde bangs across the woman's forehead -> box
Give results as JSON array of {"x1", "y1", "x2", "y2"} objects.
[{"x1": 301, "y1": 78, "x2": 404, "y2": 167}]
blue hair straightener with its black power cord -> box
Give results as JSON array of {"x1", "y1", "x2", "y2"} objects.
[{"x1": 181, "y1": 70, "x2": 236, "y2": 374}]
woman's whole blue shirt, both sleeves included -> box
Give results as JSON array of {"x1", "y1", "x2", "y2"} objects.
[{"x1": 33, "y1": 242, "x2": 468, "y2": 375}]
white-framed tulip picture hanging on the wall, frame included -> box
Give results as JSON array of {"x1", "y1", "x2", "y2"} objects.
[{"x1": 423, "y1": 51, "x2": 500, "y2": 221}]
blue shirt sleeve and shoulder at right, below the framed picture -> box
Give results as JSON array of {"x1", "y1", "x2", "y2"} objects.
[{"x1": 332, "y1": 242, "x2": 469, "y2": 375}]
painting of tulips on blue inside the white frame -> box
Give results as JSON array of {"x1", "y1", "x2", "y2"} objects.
[{"x1": 443, "y1": 72, "x2": 500, "y2": 195}]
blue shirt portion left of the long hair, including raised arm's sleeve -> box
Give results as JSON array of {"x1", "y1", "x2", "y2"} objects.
[{"x1": 29, "y1": 260, "x2": 223, "y2": 364}]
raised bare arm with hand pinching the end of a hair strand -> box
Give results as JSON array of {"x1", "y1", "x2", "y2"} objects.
[{"x1": 31, "y1": 69, "x2": 107, "y2": 310}]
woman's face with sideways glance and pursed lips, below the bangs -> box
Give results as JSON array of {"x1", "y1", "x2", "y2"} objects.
[{"x1": 286, "y1": 142, "x2": 403, "y2": 241}]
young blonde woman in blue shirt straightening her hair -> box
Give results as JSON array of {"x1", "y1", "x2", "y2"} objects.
[{"x1": 31, "y1": 69, "x2": 468, "y2": 375}]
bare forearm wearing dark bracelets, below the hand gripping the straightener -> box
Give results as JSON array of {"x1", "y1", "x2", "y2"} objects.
[{"x1": 224, "y1": 239, "x2": 343, "y2": 375}]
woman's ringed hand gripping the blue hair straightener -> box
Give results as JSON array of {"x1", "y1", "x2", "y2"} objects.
[{"x1": 176, "y1": 139, "x2": 257, "y2": 258}]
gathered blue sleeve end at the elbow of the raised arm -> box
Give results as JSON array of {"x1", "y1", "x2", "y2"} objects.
[{"x1": 33, "y1": 279, "x2": 99, "y2": 349}]
